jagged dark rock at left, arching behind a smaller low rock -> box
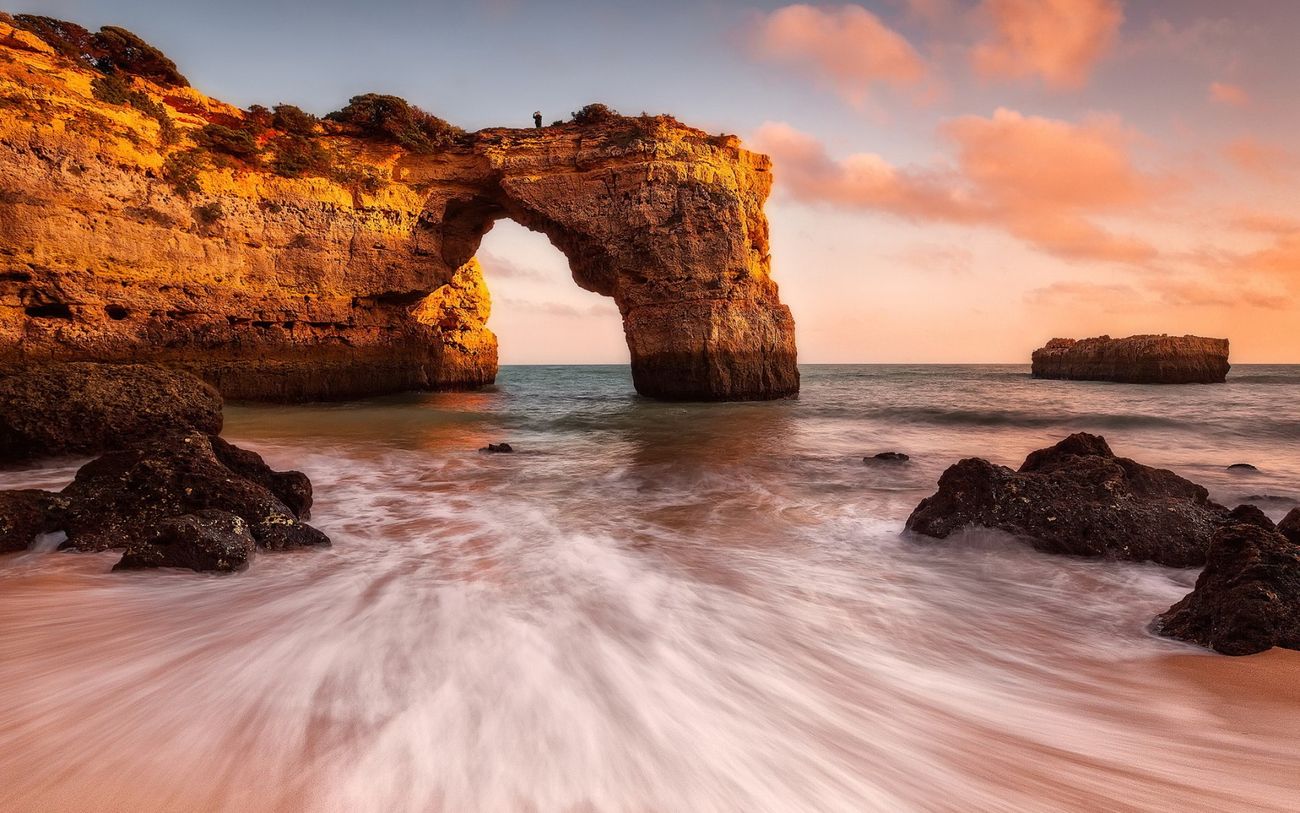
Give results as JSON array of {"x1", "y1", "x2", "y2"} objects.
[{"x1": 61, "y1": 432, "x2": 329, "y2": 550}]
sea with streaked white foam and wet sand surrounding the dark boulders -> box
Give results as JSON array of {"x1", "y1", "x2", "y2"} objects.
[{"x1": 0, "y1": 366, "x2": 1300, "y2": 813}]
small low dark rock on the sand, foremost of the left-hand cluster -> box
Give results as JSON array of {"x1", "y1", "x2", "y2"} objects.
[{"x1": 113, "y1": 509, "x2": 256, "y2": 572}]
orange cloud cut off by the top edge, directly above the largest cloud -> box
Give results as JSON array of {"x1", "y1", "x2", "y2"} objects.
[{"x1": 971, "y1": 0, "x2": 1125, "y2": 88}]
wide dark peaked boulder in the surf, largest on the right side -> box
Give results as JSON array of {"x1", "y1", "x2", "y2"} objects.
[{"x1": 907, "y1": 433, "x2": 1227, "y2": 567}]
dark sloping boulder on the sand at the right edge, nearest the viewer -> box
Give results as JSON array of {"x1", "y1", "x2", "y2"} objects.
[{"x1": 1154, "y1": 523, "x2": 1300, "y2": 654}]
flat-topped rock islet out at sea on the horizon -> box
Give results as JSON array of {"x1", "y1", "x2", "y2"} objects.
[{"x1": 1034, "y1": 334, "x2": 1229, "y2": 384}]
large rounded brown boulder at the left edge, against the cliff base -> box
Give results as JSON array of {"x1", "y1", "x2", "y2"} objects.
[{"x1": 0, "y1": 362, "x2": 222, "y2": 464}]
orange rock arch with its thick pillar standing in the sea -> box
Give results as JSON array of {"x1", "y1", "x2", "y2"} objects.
[{"x1": 439, "y1": 118, "x2": 800, "y2": 401}]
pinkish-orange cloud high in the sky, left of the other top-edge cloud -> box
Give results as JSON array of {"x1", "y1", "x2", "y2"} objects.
[{"x1": 751, "y1": 5, "x2": 928, "y2": 104}]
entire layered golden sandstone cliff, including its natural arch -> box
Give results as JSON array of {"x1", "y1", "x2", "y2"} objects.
[{"x1": 0, "y1": 18, "x2": 798, "y2": 399}]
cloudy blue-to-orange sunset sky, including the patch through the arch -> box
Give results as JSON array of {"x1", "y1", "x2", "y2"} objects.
[{"x1": 20, "y1": 0, "x2": 1300, "y2": 363}]
